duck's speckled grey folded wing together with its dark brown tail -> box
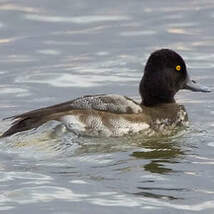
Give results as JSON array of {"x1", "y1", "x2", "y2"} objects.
[{"x1": 1, "y1": 94, "x2": 142, "y2": 137}]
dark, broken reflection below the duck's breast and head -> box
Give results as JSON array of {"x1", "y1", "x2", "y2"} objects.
[{"x1": 131, "y1": 133, "x2": 187, "y2": 200}]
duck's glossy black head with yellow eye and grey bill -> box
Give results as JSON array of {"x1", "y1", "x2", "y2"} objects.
[{"x1": 139, "y1": 49, "x2": 211, "y2": 106}]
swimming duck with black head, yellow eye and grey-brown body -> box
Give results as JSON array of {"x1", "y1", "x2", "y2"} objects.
[{"x1": 1, "y1": 49, "x2": 210, "y2": 137}]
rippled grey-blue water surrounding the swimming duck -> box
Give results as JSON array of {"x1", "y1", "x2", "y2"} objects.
[{"x1": 0, "y1": 0, "x2": 214, "y2": 214}]
